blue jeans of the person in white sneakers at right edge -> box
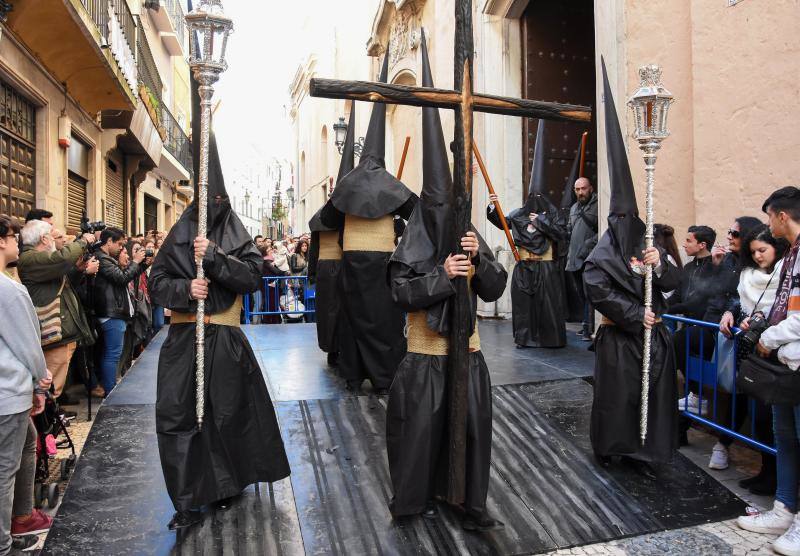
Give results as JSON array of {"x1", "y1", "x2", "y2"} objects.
[{"x1": 772, "y1": 405, "x2": 800, "y2": 512}]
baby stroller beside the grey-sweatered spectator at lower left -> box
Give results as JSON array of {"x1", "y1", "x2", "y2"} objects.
[{"x1": 33, "y1": 392, "x2": 77, "y2": 508}]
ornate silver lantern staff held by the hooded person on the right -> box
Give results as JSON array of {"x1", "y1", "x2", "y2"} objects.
[{"x1": 628, "y1": 65, "x2": 673, "y2": 446}]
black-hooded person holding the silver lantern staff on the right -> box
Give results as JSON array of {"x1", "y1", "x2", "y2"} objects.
[{"x1": 583, "y1": 60, "x2": 680, "y2": 477}]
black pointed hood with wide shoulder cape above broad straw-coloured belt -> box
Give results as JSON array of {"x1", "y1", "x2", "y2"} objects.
[{"x1": 323, "y1": 50, "x2": 414, "y2": 220}]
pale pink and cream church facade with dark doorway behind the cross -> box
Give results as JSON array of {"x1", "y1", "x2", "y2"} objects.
[{"x1": 292, "y1": 0, "x2": 800, "y2": 316}]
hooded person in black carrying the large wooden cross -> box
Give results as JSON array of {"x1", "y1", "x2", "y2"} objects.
[{"x1": 386, "y1": 36, "x2": 507, "y2": 530}]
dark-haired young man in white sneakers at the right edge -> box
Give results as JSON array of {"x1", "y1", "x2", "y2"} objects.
[{"x1": 737, "y1": 187, "x2": 800, "y2": 554}]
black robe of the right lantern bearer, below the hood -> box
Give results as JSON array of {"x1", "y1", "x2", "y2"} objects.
[{"x1": 583, "y1": 237, "x2": 680, "y2": 463}]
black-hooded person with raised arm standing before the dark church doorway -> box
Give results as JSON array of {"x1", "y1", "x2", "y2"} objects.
[{"x1": 486, "y1": 120, "x2": 567, "y2": 348}]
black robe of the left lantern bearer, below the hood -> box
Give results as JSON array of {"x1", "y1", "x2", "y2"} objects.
[{"x1": 150, "y1": 207, "x2": 289, "y2": 511}]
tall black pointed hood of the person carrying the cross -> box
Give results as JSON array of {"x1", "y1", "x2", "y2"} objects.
[{"x1": 392, "y1": 28, "x2": 454, "y2": 273}]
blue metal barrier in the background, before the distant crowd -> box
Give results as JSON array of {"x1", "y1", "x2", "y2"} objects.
[{"x1": 243, "y1": 276, "x2": 316, "y2": 324}]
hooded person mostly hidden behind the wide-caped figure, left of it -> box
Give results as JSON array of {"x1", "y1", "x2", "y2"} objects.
[{"x1": 308, "y1": 110, "x2": 356, "y2": 366}]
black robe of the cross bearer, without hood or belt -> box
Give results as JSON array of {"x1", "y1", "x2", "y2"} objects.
[{"x1": 386, "y1": 239, "x2": 508, "y2": 516}]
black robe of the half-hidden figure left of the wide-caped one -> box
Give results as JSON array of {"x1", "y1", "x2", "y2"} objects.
[{"x1": 308, "y1": 231, "x2": 342, "y2": 353}]
